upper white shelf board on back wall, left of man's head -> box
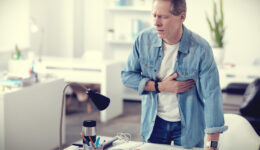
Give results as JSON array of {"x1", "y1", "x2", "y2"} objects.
[{"x1": 108, "y1": 6, "x2": 151, "y2": 13}]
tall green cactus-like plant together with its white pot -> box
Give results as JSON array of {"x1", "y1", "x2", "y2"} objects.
[{"x1": 206, "y1": 0, "x2": 225, "y2": 67}]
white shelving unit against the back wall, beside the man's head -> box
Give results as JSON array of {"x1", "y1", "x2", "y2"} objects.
[{"x1": 104, "y1": 0, "x2": 152, "y2": 100}]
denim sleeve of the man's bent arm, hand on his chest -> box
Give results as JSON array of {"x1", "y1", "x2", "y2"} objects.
[{"x1": 121, "y1": 38, "x2": 150, "y2": 95}]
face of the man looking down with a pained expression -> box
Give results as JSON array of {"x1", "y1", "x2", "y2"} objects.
[{"x1": 152, "y1": 0, "x2": 185, "y2": 41}]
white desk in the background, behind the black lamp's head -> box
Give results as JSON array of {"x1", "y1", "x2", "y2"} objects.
[{"x1": 9, "y1": 57, "x2": 123, "y2": 122}]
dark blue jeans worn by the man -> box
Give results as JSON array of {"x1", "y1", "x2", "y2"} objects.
[{"x1": 148, "y1": 116, "x2": 181, "y2": 146}]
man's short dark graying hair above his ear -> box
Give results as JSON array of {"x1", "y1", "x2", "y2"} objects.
[{"x1": 153, "y1": 0, "x2": 187, "y2": 16}]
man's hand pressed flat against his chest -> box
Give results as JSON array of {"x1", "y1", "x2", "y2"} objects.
[{"x1": 158, "y1": 73, "x2": 195, "y2": 93}]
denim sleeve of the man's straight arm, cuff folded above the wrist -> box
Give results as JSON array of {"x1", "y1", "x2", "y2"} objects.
[{"x1": 199, "y1": 45, "x2": 228, "y2": 133}]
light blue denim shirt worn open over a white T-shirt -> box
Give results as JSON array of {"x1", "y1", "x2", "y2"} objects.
[{"x1": 121, "y1": 25, "x2": 227, "y2": 148}]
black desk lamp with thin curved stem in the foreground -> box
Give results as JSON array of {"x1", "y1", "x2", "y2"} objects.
[{"x1": 59, "y1": 82, "x2": 110, "y2": 150}]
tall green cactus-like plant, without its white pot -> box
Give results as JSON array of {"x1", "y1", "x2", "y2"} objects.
[{"x1": 206, "y1": 0, "x2": 225, "y2": 48}]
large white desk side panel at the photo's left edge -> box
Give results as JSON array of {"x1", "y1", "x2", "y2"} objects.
[{"x1": 0, "y1": 79, "x2": 66, "y2": 150}]
